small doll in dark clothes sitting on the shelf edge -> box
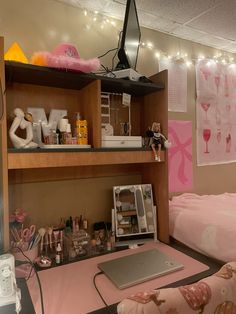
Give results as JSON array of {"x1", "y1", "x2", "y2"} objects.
[{"x1": 146, "y1": 122, "x2": 171, "y2": 161}]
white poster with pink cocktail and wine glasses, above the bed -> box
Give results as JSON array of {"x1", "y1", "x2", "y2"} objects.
[{"x1": 196, "y1": 60, "x2": 236, "y2": 166}]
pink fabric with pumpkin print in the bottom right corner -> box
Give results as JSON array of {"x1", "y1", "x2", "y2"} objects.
[{"x1": 118, "y1": 262, "x2": 236, "y2": 314}]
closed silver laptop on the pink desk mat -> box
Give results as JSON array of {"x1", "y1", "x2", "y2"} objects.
[{"x1": 97, "y1": 249, "x2": 184, "y2": 289}]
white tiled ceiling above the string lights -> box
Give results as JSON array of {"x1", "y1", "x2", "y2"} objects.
[{"x1": 57, "y1": 0, "x2": 236, "y2": 53}]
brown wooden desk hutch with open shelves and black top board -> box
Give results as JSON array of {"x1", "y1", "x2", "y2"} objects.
[{"x1": 0, "y1": 37, "x2": 169, "y2": 248}]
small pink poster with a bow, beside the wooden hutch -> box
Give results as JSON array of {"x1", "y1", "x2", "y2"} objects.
[{"x1": 168, "y1": 120, "x2": 193, "y2": 192}]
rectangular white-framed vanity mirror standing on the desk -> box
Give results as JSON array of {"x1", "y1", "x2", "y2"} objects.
[{"x1": 113, "y1": 184, "x2": 156, "y2": 237}]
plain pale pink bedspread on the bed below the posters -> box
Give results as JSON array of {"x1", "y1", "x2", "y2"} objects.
[{"x1": 169, "y1": 193, "x2": 236, "y2": 262}]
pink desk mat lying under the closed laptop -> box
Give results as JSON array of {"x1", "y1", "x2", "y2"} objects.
[{"x1": 28, "y1": 242, "x2": 209, "y2": 314}]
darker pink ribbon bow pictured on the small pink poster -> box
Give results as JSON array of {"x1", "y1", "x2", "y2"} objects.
[{"x1": 168, "y1": 127, "x2": 192, "y2": 184}]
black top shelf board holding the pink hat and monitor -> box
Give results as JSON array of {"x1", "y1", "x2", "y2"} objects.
[{"x1": 5, "y1": 61, "x2": 164, "y2": 96}]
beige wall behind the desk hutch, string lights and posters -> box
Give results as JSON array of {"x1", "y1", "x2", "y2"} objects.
[{"x1": 0, "y1": 0, "x2": 236, "y2": 228}]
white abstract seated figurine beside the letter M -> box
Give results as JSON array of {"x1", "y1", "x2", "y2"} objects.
[{"x1": 9, "y1": 108, "x2": 38, "y2": 148}]
